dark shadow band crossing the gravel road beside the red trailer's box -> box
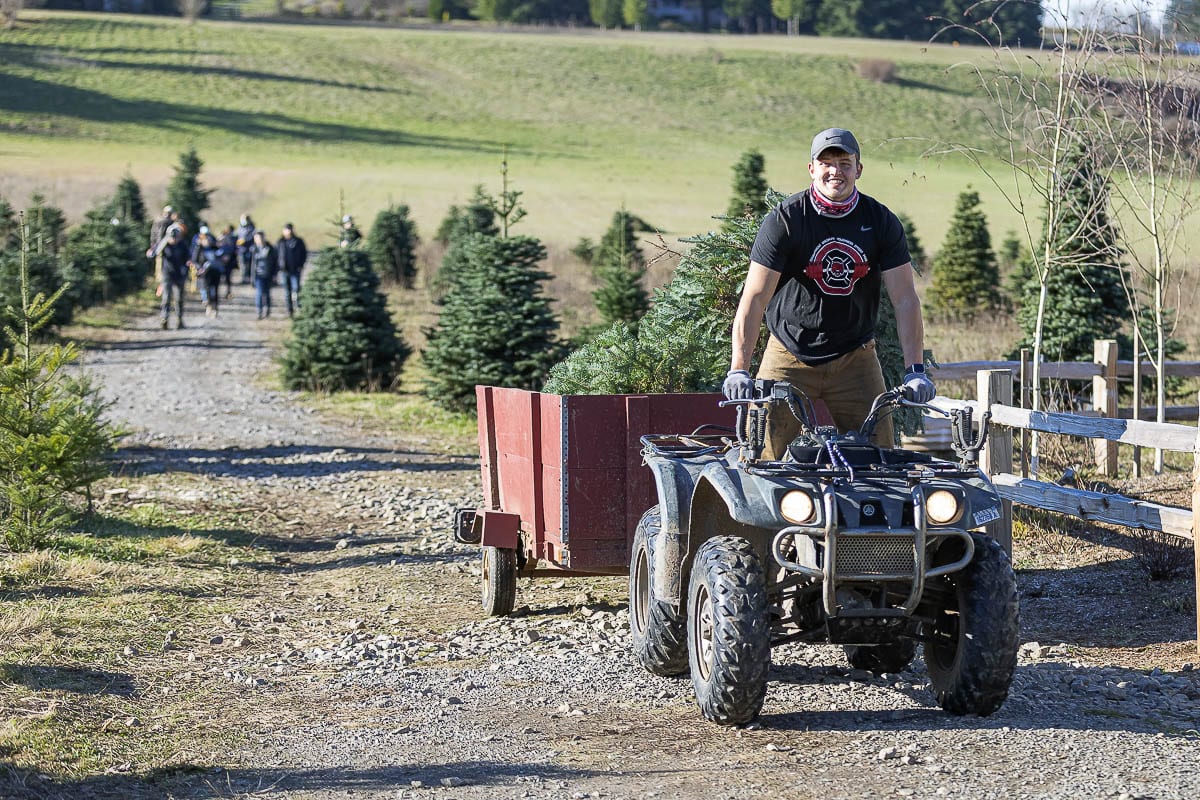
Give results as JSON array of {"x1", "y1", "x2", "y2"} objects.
[{"x1": 115, "y1": 445, "x2": 479, "y2": 477}]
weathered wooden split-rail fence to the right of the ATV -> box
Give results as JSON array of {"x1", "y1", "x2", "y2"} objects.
[{"x1": 934, "y1": 359, "x2": 1200, "y2": 652}]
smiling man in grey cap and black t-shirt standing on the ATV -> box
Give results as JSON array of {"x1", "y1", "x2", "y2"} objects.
[{"x1": 722, "y1": 128, "x2": 936, "y2": 459}]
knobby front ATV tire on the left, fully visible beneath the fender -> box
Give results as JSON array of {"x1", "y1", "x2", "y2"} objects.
[{"x1": 688, "y1": 536, "x2": 770, "y2": 724}]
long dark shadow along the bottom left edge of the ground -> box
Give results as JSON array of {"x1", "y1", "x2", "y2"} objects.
[{"x1": 0, "y1": 759, "x2": 614, "y2": 800}]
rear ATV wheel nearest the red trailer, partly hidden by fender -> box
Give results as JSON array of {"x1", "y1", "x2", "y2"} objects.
[{"x1": 629, "y1": 506, "x2": 688, "y2": 678}]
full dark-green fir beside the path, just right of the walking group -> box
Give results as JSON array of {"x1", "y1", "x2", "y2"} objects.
[{"x1": 282, "y1": 247, "x2": 410, "y2": 392}]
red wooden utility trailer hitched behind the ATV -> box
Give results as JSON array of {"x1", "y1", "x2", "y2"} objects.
[{"x1": 455, "y1": 386, "x2": 736, "y2": 615}]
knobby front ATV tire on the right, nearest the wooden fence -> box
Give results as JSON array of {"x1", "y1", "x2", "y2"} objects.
[{"x1": 925, "y1": 534, "x2": 1019, "y2": 716}]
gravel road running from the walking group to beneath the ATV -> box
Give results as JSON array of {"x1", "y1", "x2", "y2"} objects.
[{"x1": 37, "y1": 288, "x2": 1200, "y2": 800}]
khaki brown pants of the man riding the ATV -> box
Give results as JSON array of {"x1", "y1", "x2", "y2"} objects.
[{"x1": 758, "y1": 336, "x2": 895, "y2": 461}]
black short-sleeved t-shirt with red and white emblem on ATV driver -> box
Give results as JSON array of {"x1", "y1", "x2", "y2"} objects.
[{"x1": 750, "y1": 188, "x2": 911, "y2": 365}]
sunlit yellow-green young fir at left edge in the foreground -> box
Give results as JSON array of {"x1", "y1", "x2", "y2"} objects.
[{"x1": 0, "y1": 221, "x2": 118, "y2": 551}]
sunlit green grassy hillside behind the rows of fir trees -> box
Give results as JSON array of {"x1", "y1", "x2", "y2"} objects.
[{"x1": 0, "y1": 13, "x2": 1013, "y2": 246}]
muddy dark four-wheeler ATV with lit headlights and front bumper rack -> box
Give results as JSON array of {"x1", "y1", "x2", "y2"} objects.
[{"x1": 629, "y1": 381, "x2": 1018, "y2": 724}]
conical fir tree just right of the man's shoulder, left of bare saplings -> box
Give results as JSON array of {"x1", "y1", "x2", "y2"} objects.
[{"x1": 928, "y1": 190, "x2": 1001, "y2": 320}]
